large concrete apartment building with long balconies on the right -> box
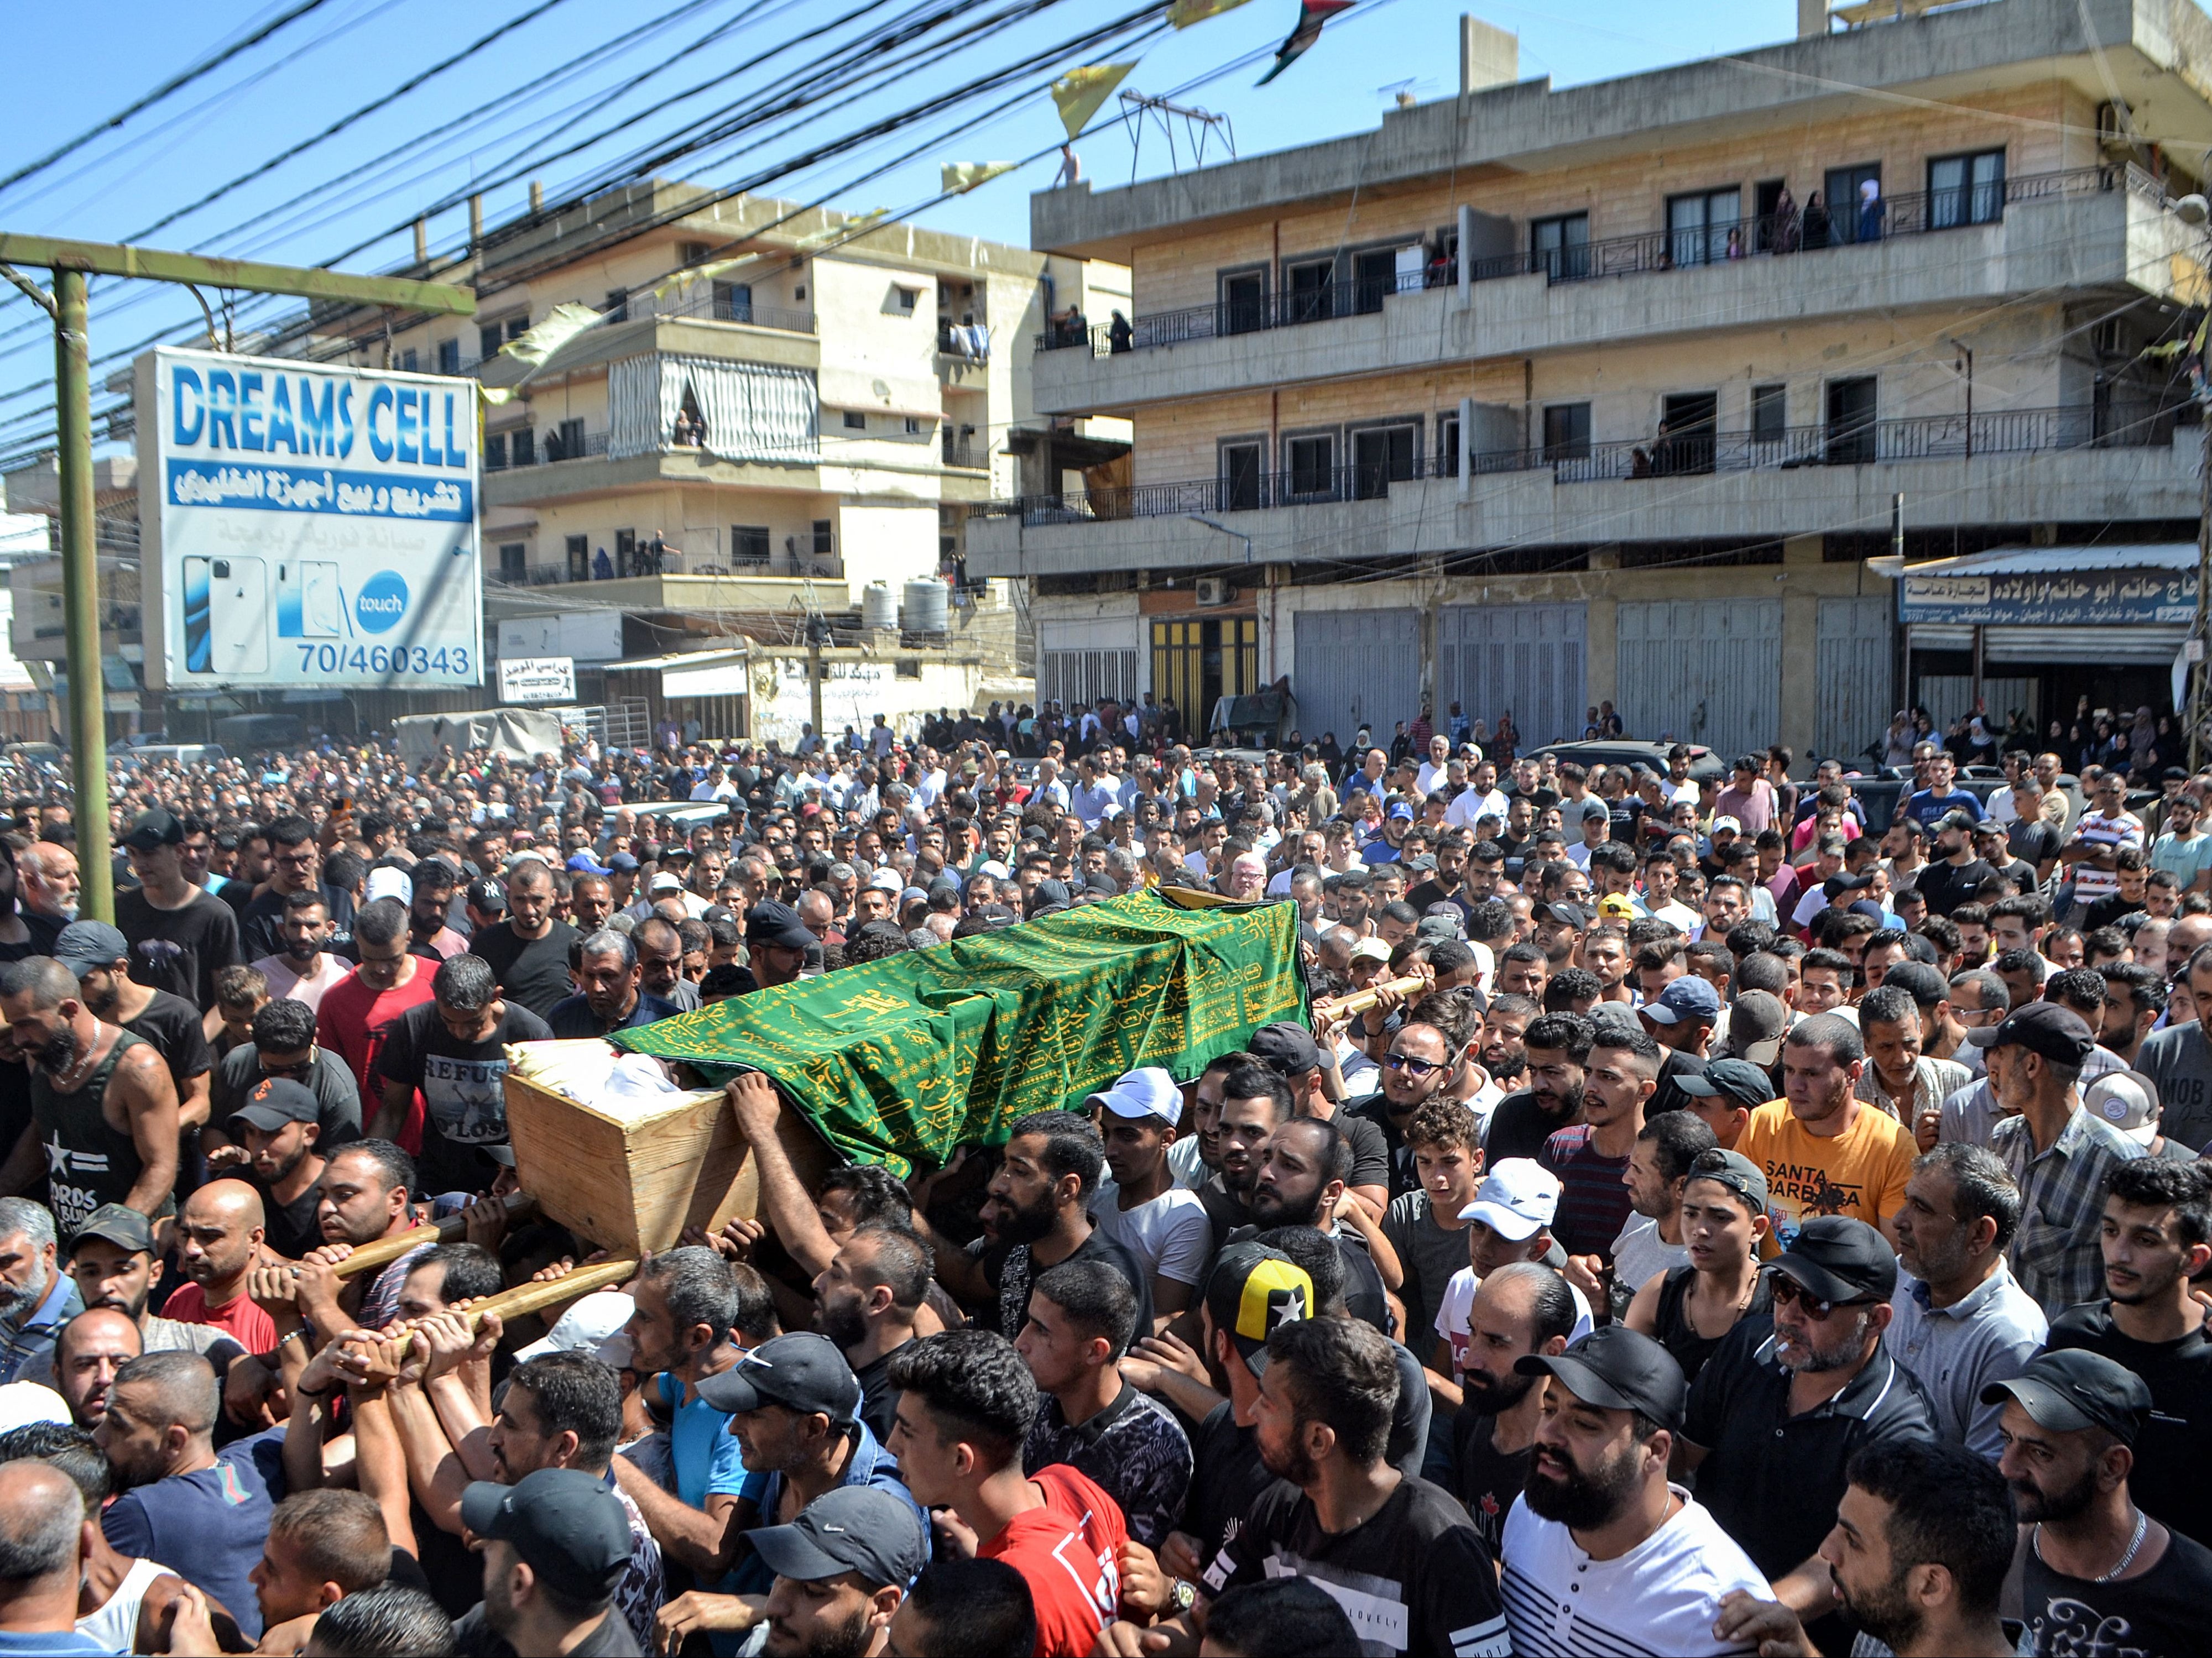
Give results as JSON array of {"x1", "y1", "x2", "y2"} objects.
[{"x1": 967, "y1": 0, "x2": 2212, "y2": 754}]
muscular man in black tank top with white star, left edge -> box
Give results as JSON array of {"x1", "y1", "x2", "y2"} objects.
[{"x1": 0, "y1": 955, "x2": 180, "y2": 1229}]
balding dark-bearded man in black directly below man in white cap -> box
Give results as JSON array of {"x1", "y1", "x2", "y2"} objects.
[{"x1": 1451, "y1": 1260, "x2": 1577, "y2": 1554}]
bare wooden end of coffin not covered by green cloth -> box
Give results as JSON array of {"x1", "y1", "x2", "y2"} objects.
[{"x1": 507, "y1": 1070, "x2": 832, "y2": 1256}]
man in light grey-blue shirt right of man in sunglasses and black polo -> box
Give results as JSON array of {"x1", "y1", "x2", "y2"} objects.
[{"x1": 1889, "y1": 1143, "x2": 2051, "y2": 1461}]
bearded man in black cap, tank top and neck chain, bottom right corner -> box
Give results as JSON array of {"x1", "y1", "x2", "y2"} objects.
[{"x1": 1982, "y1": 1348, "x2": 2212, "y2": 1658}]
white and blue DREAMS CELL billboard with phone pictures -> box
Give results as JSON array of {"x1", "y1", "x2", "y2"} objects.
[{"x1": 135, "y1": 347, "x2": 484, "y2": 690}]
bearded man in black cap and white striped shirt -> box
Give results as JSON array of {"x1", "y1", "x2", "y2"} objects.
[{"x1": 1502, "y1": 1324, "x2": 1767, "y2": 1658}]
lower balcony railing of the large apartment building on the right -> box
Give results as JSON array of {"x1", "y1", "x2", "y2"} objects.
[{"x1": 984, "y1": 409, "x2": 2174, "y2": 524}]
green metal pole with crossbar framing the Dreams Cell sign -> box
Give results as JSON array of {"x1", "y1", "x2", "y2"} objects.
[{"x1": 0, "y1": 234, "x2": 476, "y2": 922}]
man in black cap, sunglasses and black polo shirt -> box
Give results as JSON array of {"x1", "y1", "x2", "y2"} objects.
[{"x1": 1683, "y1": 1216, "x2": 1936, "y2": 1654}]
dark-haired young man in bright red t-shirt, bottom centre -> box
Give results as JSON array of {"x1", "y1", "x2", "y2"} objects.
[{"x1": 891, "y1": 1331, "x2": 1128, "y2": 1658}]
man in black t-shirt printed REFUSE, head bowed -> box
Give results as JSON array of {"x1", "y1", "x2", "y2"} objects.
[{"x1": 372, "y1": 955, "x2": 553, "y2": 1191}]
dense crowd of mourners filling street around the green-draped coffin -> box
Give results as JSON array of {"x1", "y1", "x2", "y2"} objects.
[{"x1": 0, "y1": 710, "x2": 2212, "y2": 1658}]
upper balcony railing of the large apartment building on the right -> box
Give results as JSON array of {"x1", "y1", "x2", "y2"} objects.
[{"x1": 1037, "y1": 164, "x2": 2166, "y2": 356}]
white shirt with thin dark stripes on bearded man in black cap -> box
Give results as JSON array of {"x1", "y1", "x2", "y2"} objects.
[{"x1": 1500, "y1": 1486, "x2": 1772, "y2": 1658}]
